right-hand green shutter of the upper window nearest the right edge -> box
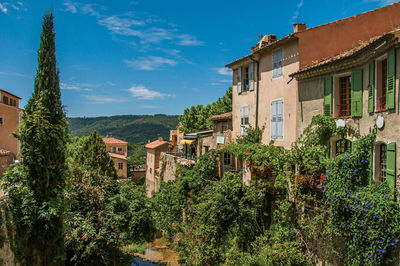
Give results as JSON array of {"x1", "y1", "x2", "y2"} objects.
[{"x1": 386, "y1": 48, "x2": 396, "y2": 109}]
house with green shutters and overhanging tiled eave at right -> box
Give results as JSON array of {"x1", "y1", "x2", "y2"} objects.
[{"x1": 291, "y1": 30, "x2": 400, "y2": 200}]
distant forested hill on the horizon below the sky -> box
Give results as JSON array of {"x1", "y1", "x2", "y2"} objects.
[{"x1": 68, "y1": 114, "x2": 178, "y2": 143}]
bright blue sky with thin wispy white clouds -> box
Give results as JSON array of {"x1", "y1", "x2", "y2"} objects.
[{"x1": 0, "y1": 0, "x2": 395, "y2": 117}]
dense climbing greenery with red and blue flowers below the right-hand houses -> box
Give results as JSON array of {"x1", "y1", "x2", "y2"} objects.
[{"x1": 152, "y1": 116, "x2": 400, "y2": 265}]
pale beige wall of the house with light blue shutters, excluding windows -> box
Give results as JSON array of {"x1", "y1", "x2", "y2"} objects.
[{"x1": 232, "y1": 40, "x2": 299, "y2": 149}]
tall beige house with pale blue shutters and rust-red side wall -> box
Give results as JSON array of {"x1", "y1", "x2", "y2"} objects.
[{"x1": 226, "y1": 2, "x2": 400, "y2": 149}]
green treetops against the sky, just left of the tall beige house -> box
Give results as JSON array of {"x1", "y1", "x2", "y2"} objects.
[{"x1": 179, "y1": 87, "x2": 232, "y2": 132}]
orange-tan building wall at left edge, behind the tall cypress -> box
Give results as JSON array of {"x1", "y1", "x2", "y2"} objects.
[{"x1": 0, "y1": 102, "x2": 22, "y2": 156}]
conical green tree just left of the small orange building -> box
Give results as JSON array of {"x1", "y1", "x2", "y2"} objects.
[{"x1": 74, "y1": 131, "x2": 117, "y2": 178}]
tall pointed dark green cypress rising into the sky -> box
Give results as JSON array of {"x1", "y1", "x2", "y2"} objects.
[{"x1": 4, "y1": 12, "x2": 68, "y2": 265}]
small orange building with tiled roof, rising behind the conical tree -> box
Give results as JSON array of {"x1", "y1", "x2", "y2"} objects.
[{"x1": 103, "y1": 137, "x2": 128, "y2": 178}]
